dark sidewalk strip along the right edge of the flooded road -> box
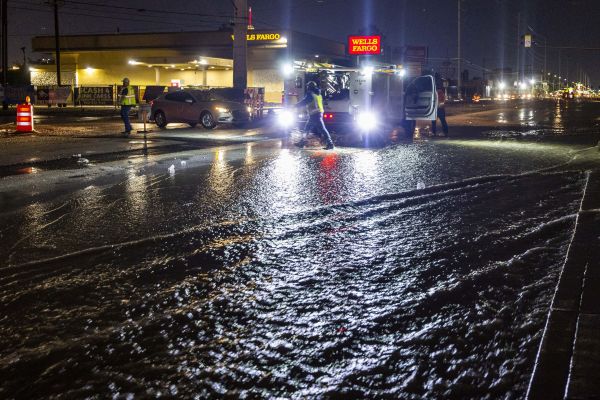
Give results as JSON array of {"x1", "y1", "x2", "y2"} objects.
[{"x1": 527, "y1": 172, "x2": 600, "y2": 400}]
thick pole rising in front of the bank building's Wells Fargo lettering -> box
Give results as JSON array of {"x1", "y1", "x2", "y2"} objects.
[{"x1": 233, "y1": 0, "x2": 248, "y2": 89}]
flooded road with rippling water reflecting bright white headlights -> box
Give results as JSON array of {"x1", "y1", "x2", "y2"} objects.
[{"x1": 0, "y1": 99, "x2": 596, "y2": 399}]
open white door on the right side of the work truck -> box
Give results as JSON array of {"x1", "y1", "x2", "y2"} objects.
[{"x1": 404, "y1": 75, "x2": 438, "y2": 121}]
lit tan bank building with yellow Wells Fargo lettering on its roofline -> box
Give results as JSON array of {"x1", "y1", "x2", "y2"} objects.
[{"x1": 31, "y1": 30, "x2": 349, "y2": 102}]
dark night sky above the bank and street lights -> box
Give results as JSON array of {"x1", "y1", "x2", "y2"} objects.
[{"x1": 9, "y1": 0, "x2": 600, "y2": 84}]
